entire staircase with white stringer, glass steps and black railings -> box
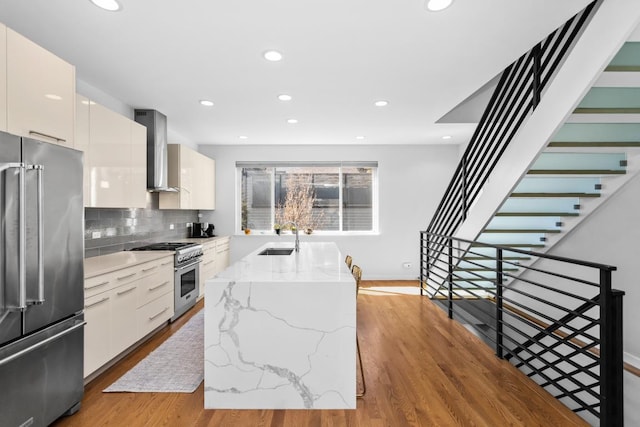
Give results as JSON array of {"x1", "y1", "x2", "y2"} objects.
[{"x1": 420, "y1": 1, "x2": 640, "y2": 425}]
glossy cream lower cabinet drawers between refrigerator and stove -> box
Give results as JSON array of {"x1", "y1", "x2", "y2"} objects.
[{"x1": 84, "y1": 255, "x2": 174, "y2": 378}]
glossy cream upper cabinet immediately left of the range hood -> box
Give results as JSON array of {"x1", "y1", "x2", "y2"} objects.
[{"x1": 76, "y1": 95, "x2": 147, "y2": 208}]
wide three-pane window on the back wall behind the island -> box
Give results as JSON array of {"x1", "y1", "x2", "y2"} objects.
[{"x1": 236, "y1": 162, "x2": 378, "y2": 233}]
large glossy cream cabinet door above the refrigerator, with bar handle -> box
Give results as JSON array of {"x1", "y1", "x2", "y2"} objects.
[{"x1": 5, "y1": 28, "x2": 76, "y2": 147}]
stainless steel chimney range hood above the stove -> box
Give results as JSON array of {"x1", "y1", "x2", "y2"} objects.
[{"x1": 135, "y1": 109, "x2": 178, "y2": 192}]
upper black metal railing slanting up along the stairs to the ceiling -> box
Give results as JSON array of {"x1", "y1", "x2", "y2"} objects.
[{"x1": 427, "y1": 0, "x2": 602, "y2": 294}]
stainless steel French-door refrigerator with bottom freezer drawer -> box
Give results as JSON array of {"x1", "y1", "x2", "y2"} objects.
[{"x1": 0, "y1": 132, "x2": 84, "y2": 427}]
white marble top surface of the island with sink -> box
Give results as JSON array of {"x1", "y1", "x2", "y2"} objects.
[{"x1": 214, "y1": 242, "x2": 353, "y2": 284}]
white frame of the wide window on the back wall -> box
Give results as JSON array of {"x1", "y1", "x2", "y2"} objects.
[{"x1": 235, "y1": 161, "x2": 380, "y2": 236}]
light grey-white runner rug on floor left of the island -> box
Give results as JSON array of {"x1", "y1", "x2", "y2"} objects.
[{"x1": 103, "y1": 310, "x2": 204, "y2": 393}]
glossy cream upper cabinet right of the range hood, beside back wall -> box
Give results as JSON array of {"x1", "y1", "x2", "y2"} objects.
[{"x1": 159, "y1": 144, "x2": 216, "y2": 210}]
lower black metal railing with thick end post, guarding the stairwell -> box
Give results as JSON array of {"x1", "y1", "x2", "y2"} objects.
[{"x1": 420, "y1": 231, "x2": 624, "y2": 426}]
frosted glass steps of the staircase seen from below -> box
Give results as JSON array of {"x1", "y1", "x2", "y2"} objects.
[{"x1": 454, "y1": 42, "x2": 640, "y2": 297}]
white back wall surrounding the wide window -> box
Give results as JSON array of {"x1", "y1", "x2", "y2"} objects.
[{"x1": 199, "y1": 145, "x2": 458, "y2": 279}]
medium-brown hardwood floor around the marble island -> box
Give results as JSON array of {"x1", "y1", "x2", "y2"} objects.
[{"x1": 54, "y1": 281, "x2": 586, "y2": 427}]
